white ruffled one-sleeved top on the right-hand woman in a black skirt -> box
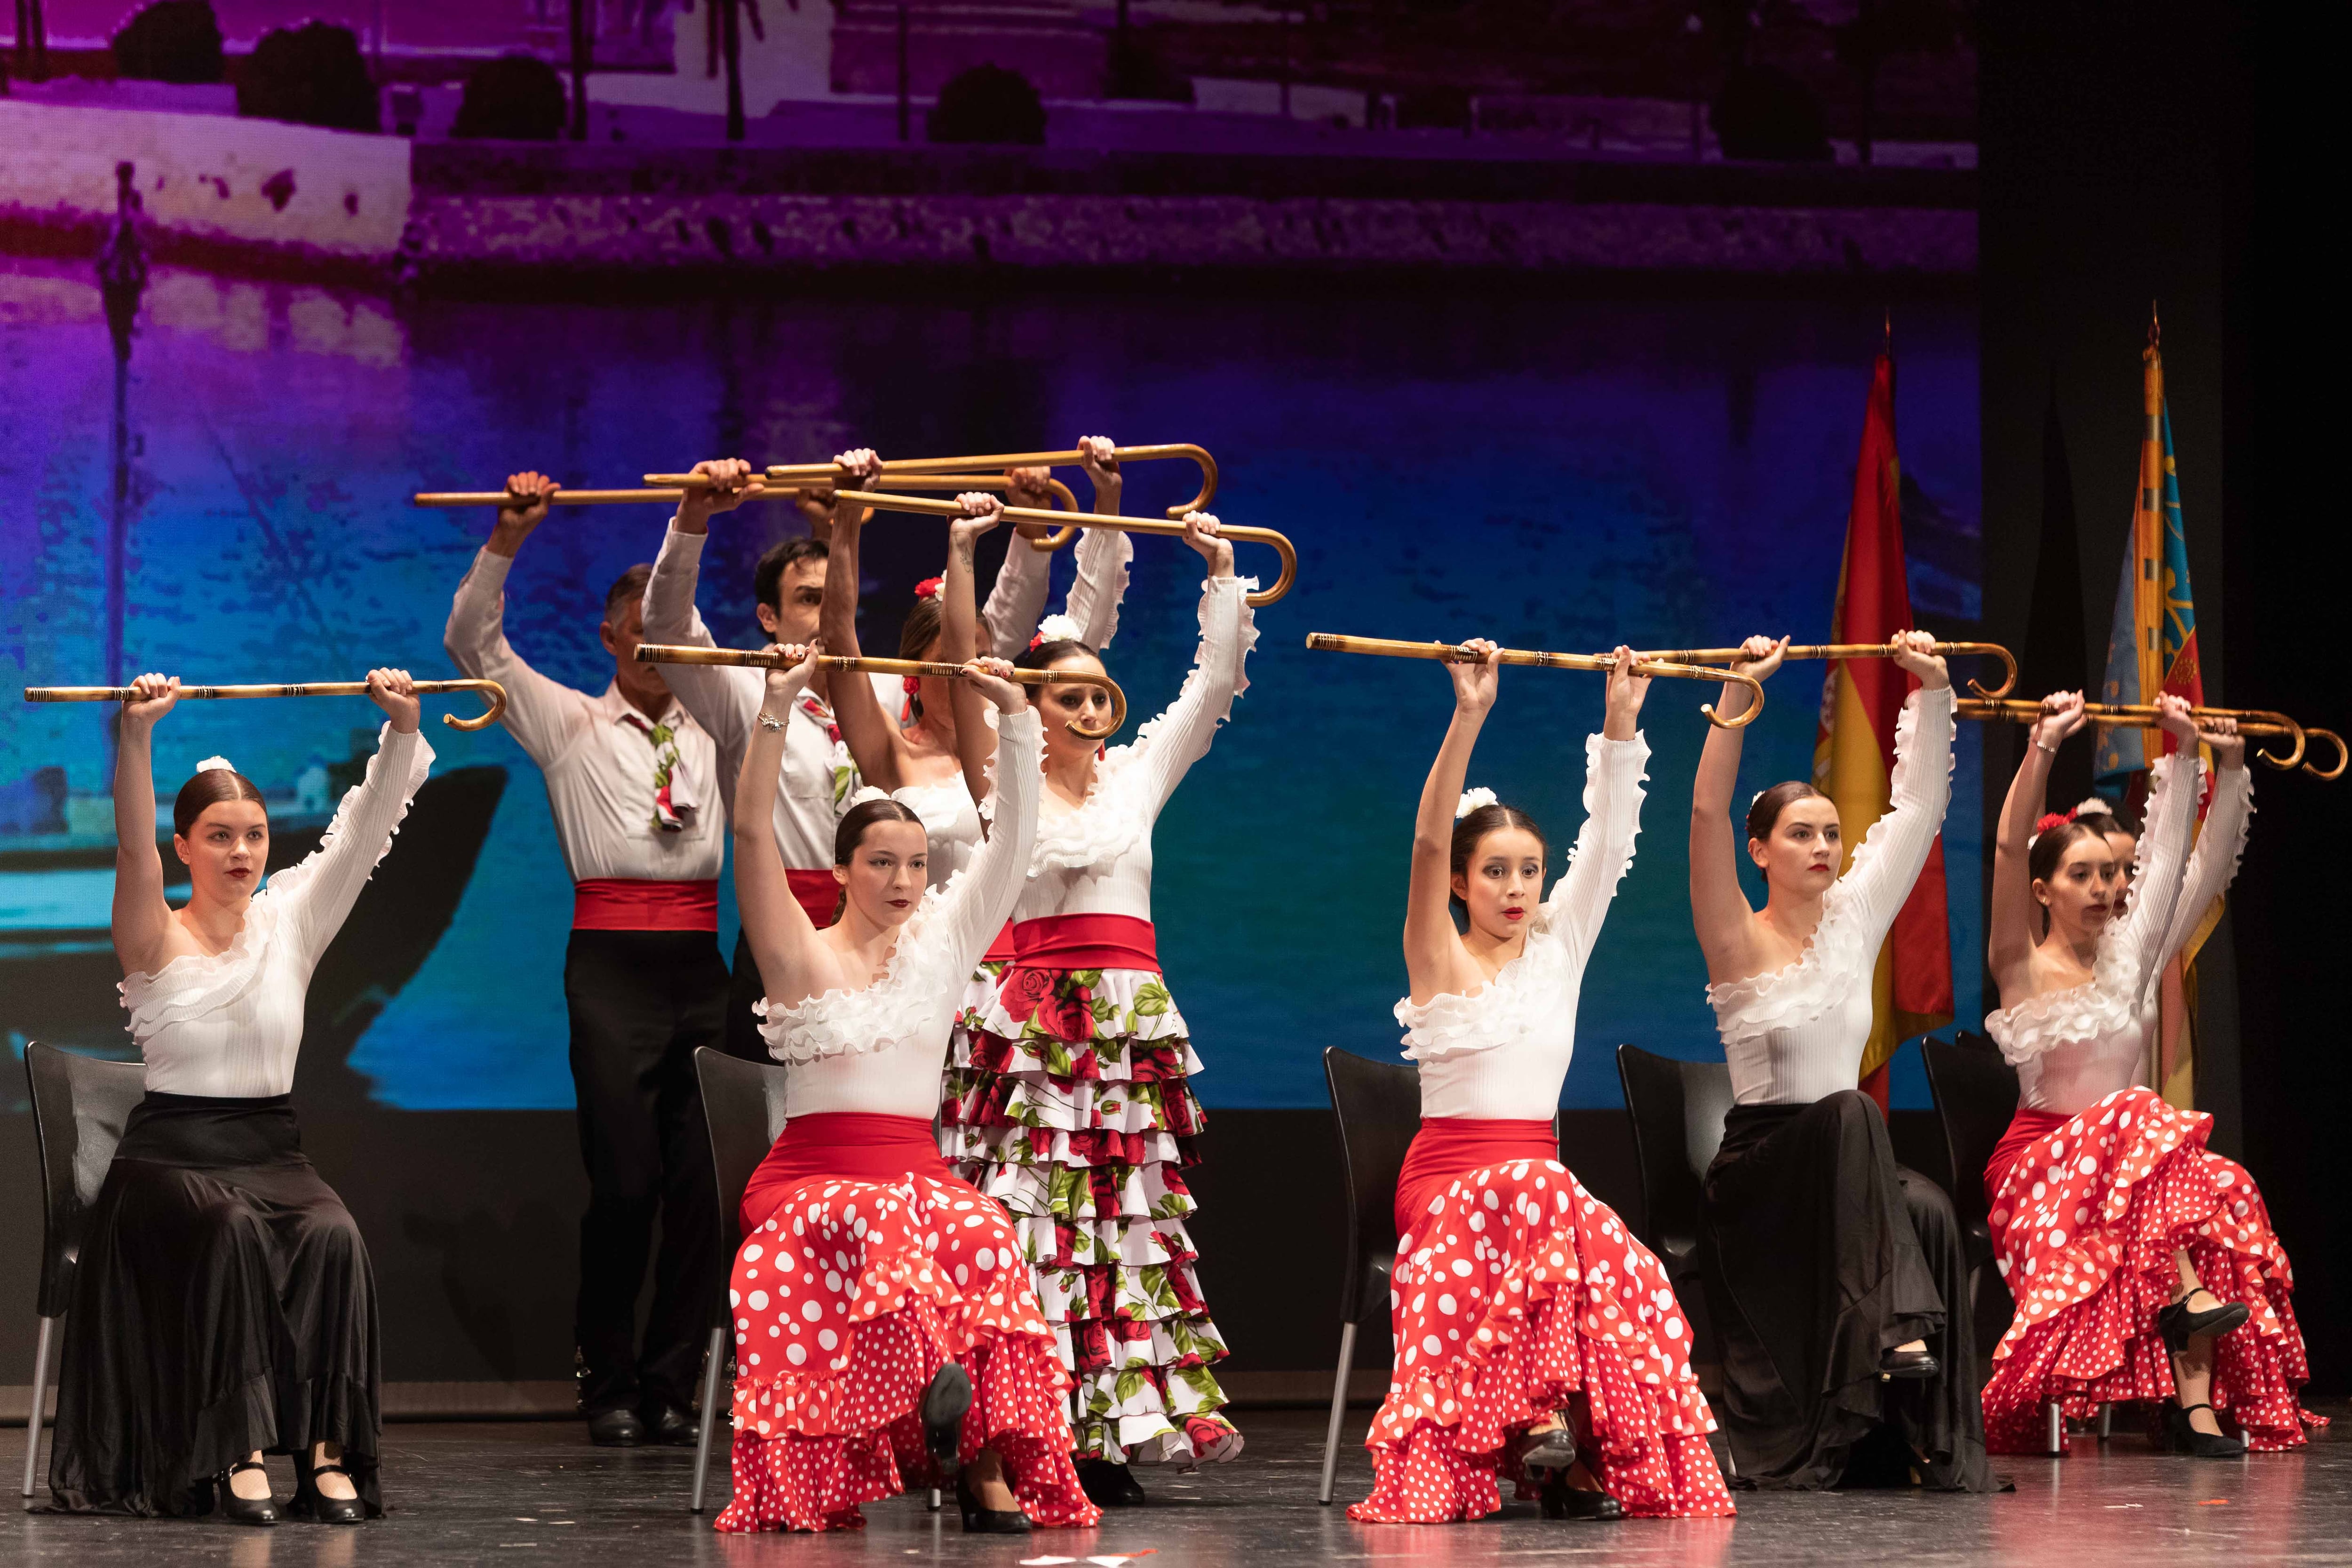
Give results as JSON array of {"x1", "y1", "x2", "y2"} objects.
[{"x1": 1708, "y1": 686, "x2": 1952, "y2": 1105}]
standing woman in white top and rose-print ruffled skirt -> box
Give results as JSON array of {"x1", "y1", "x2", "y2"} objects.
[{"x1": 941, "y1": 512, "x2": 1258, "y2": 1504}]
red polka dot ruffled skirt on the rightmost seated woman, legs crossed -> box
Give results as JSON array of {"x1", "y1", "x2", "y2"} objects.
[{"x1": 1985, "y1": 1089, "x2": 2326, "y2": 1453}]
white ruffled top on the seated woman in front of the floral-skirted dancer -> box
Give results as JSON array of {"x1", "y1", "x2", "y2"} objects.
[{"x1": 753, "y1": 708, "x2": 1044, "y2": 1122}]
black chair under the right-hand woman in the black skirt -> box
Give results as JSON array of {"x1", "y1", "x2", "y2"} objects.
[{"x1": 1618, "y1": 1046, "x2": 1731, "y2": 1401}]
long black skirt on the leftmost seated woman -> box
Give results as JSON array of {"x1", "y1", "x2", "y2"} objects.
[{"x1": 49, "y1": 1093, "x2": 383, "y2": 1516}]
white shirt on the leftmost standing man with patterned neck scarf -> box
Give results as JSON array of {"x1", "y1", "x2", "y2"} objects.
[{"x1": 442, "y1": 550, "x2": 727, "y2": 882}]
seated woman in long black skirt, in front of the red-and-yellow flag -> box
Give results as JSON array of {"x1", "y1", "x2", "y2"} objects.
[{"x1": 1691, "y1": 632, "x2": 1992, "y2": 1490}]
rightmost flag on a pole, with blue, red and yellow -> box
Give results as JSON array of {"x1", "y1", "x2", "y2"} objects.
[{"x1": 2093, "y1": 320, "x2": 2223, "y2": 1110}]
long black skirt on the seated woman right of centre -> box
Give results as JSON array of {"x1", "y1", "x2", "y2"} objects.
[{"x1": 1705, "y1": 1091, "x2": 1997, "y2": 1493}]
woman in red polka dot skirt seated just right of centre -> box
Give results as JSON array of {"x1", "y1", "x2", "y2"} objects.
[{"x1": 1348, "y1": 642, "x2": 1731, "y2": 1523}]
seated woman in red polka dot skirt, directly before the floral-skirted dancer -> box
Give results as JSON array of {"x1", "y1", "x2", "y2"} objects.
[{"x1": 717, "y1": 630, "x2": 1096, "y2": 1533}]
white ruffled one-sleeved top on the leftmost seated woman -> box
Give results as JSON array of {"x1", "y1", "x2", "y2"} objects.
[{"x1": 118, "y1": 724, "x2": 433, "y2": 1100}]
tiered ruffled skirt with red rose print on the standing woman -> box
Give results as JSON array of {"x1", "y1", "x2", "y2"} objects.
[{"x1": 938, "y1": 917, "x2": 1242, "y2": 1467}]
